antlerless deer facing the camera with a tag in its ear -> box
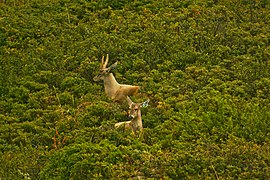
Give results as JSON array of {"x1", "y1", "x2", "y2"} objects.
[{"x1": 114, "y1": 97, "x2": 150, "y2": 135}]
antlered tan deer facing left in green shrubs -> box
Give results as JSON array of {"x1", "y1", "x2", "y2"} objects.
[{"x1": 93, "y1": 54, "x2": 140, "y2": 102}]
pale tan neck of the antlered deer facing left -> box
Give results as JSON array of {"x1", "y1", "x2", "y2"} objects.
[{"x1": 104, "y1": 73, "x2": 120, "y2": 98}]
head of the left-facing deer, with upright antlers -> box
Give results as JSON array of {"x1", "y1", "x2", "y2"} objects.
[{"x1": 93, "y1": 54, "x2": 117, "y2": 81}]
